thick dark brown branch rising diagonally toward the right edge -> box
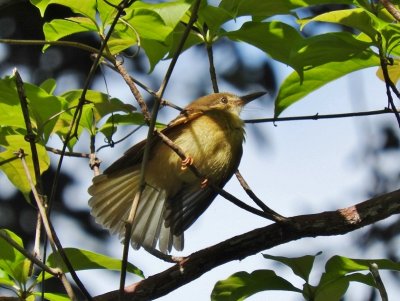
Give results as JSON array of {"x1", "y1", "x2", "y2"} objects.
[{"x1": 94, "y1": 190, "x2": 400, "y2": 301}]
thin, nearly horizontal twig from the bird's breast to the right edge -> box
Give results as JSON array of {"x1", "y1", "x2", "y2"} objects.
[{"x1": 243, "y1": 108, "x2": 397, "y2": 123}]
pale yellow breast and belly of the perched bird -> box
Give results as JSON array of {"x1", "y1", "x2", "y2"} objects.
[{"x1": 146, "y1": 110, "x2": 245, "y2": 194}]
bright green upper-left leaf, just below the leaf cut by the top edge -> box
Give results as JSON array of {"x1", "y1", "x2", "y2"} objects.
[{"x1": 43, "y1": 17, "x2": 97, "y2": 50}]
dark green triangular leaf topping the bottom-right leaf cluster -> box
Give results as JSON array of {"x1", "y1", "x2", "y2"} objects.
[{"x1": 263, "y1": 252, "x2": 321, "y2": 282}]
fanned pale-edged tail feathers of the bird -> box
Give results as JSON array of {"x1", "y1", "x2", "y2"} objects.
[{"x1": 89, "y1": 169, "x2": 183, "y2": 253}]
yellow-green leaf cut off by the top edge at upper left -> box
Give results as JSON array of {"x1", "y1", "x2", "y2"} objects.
[{"x1": 30, "y1": 0, "x2": 96, "y2": 21}]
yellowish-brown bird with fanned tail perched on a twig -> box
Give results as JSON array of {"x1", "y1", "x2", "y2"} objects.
[{"x1": 88, "y1": 92, "x2": 265, "y2": 254}]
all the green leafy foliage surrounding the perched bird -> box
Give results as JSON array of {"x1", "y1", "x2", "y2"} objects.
[{"x1": 0, "y1": 0, "x2": 400, "y2": 300}]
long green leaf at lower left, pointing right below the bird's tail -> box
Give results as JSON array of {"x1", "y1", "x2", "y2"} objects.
[{"x1": 38, "y1": 248, "x2": 144, "y2": 281}]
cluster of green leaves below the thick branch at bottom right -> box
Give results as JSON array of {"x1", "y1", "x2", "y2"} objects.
[{"x1": 211, "y1": 253, "x2": 400, "y2": 301}]
